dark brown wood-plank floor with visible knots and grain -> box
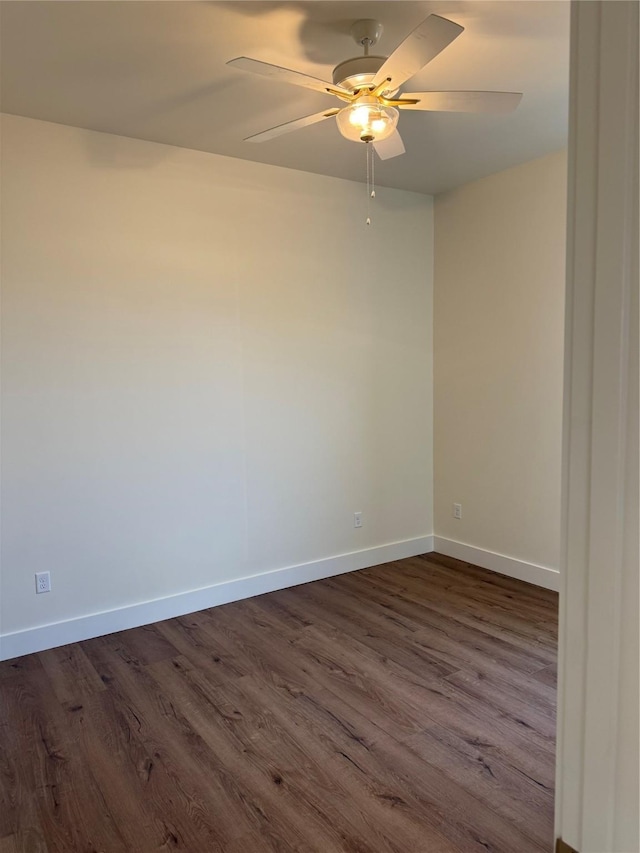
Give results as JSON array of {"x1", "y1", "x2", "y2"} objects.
[{"x1": 0, "y1": 554, "x2": 557, "y2": 853}]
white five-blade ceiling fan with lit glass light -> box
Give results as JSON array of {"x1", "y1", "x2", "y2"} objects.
[{"x1": 227, "y1": 15, "x2": 522, "y2": 160}]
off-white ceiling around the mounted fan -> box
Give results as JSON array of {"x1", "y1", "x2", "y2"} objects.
[{"x1": 0, "y1": 0, "x2": 569, "y2": 193}]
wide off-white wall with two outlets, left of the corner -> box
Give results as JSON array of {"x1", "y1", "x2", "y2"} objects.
[{"x1": 0, "y1": 116, "x2": 432, "y2": 656}]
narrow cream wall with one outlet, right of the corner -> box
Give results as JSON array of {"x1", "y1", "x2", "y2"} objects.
[{"x1": 434, "y1": 152, "x2": 566, "y2": 587}]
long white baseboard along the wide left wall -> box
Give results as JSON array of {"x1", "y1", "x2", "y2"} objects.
[{"x1": 0, "y1": 536, "x2": 433, "y2": 660}]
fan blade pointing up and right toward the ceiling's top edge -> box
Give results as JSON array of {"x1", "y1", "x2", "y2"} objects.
[{"x1": 373, "y1": 15, "x2": 464, "y2": 89}]
